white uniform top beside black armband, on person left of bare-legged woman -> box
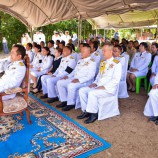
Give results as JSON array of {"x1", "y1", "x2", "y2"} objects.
[{"x1": 31, "y1": 53, "x2": 43, "y2": 70}]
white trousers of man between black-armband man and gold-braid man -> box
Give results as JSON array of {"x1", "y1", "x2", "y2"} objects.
[{"x1": 57, "y1": 78, "x2": 85, "y2": 105}]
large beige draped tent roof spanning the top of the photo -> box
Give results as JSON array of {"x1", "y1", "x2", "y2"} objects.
[{"x1": 0, "y1": 0, "x2": 158, "y2": 27}]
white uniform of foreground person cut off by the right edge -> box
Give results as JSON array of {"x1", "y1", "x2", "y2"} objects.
[{"x1": 144, "y1": 73, "x2": 158, "y2": 116}]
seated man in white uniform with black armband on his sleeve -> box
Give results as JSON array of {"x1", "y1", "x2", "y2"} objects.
[{"x1": 41, "y1": 46, "x2": 76, "y2": 103}]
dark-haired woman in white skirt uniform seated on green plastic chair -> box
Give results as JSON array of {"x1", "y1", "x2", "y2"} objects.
[{"x1": 127, "y1": 42, "x2": 151, "y2": 92}]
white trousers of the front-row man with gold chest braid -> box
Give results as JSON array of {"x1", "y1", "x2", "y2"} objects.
[{"x1": 79, "y1": 87, "x2": 113, "y2": 113}]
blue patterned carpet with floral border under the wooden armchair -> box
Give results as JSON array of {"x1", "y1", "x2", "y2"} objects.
[{"x1": 0, "y1": 94, "x2": 111, "y2": 158}]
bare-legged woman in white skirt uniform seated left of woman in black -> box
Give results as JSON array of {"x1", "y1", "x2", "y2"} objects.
[{"x1": 30, "y1": 47, "x2": 53, "y2": 88}]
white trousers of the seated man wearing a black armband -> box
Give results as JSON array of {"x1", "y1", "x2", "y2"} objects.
[{"x1": 41, "y1": 75, "x2": 60, "y2": 98}]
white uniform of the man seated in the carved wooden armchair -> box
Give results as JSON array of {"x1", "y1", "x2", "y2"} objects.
[{"x1": 0, "y1": 60, "x2": 26, "y2": 100}]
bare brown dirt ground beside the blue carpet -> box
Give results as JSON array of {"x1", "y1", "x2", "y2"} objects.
[{"x1": 0, "y1": 52, "x2": 158, "y2": 158}]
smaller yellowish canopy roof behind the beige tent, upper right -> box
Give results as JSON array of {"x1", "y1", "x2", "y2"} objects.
[{"x1": 88, "y1": 10, "x2": 158, "y2": 29}]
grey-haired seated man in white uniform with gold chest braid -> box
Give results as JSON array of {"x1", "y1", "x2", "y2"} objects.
[{"x1": 77, "y1": 44, "x2": 122, "y2": 123}]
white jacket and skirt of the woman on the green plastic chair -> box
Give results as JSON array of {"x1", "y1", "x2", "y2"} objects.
[{"x1": 128, "y1": 52, "x2": 151, "y2": 77}]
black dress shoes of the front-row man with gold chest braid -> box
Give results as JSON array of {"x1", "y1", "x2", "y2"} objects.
[{"x1": 77, "y1": 112, "x2": 98, "y2": 124}]
